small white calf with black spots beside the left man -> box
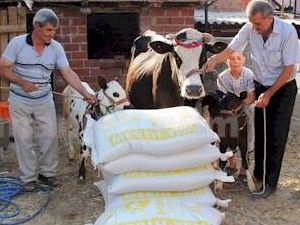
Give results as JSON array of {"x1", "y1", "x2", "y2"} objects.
[{"x1": 63, "y1": 76, "x2": 130, "y2": 181}]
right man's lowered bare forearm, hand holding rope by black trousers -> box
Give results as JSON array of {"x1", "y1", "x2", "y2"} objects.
[{"x1": 256, "y1": 65, "x2": 294, "y2": 108}]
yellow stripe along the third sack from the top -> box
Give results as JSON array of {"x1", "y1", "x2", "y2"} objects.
[{"x1": 121, "y1": 165, "x2": 209, "y2": 179}]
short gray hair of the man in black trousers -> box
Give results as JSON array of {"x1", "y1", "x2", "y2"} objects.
[{"x1": 246, "y1": 0, "x2": 273, "y2": 17}]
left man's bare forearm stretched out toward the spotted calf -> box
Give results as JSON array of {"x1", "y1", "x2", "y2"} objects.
[{"x1": 60, "y1": 66, "x2": 97, "y2": 104}]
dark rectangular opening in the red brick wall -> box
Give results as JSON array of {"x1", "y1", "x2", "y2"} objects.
[{"x1": 87, "y1": 13, "x2": 139, "y2": 59}]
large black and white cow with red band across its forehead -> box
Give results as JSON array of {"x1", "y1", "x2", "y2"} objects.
[{"x1": 126, "y1": 28, "x2": 227, "y2": 109}]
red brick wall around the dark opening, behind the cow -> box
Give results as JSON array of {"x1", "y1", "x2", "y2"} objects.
[{"x1": 54, "y1": 7, "x2": 194, "y2": 91}]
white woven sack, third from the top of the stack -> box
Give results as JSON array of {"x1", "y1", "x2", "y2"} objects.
[{"x1": 104, "y1": 165, "x2": 234, "y2": 194}]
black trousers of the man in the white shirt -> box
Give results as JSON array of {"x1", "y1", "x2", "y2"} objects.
[{"x1": 254, "y1": 80, "x2": 297, "y2": 188}]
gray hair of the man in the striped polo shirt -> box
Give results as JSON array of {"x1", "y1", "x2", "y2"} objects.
[{"x1": 32, "y1": 8, "x2": 59, "y2": 27}]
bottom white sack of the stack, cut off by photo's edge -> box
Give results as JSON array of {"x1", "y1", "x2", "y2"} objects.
[{"x1": 95, "y1": 199, "x2": 225, "y2": 225}]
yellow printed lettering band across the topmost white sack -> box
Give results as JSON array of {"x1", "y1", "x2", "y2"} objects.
[{"x1": 108, "y1": 123, "x2": 198, "y2": 146}]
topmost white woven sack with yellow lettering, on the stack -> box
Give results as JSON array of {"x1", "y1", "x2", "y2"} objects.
[{"x1": 83, "y1": 106, "x2": 219, "y2": 165}]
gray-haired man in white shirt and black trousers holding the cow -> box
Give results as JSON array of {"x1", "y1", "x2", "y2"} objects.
[{"x1": 204, "y1": 0, "x2": 300, "y2": 198}]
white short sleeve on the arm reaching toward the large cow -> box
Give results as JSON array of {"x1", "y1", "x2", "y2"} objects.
[{"x1": 228, "y1": 23, "x2": 252, "y2": 52}]
